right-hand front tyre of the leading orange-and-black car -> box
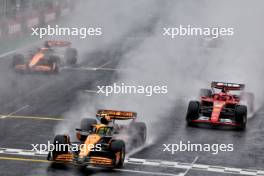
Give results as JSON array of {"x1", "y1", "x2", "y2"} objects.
[{"x1": 110, "y1": 140, "x2": 126, "y2": 168}]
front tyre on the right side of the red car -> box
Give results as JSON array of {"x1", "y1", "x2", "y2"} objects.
[{"x1": 235, "y1": 105, "x2": 247, "y2": 131}]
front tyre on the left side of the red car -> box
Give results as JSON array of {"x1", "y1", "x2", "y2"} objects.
[{"x1": 186, "y1": 101, "x2": 201, "y2": 126}]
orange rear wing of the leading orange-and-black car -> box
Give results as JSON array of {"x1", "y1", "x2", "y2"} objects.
[{"x1": 96, "y1": 109, "x2": 137, "y2": 120}]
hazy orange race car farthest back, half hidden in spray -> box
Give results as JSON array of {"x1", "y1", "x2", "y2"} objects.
[{"x1": 12, "y1": 41, "x2": 77, "y2": 73}]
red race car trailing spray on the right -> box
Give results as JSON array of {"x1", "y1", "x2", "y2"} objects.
[{"x1": 186, "y1": 82, "x2": 254, "y2": 130}]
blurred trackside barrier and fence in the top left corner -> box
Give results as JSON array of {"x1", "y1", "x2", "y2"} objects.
[{"x1": 0, "y1": 0, "x2": 78, "y2": 41}]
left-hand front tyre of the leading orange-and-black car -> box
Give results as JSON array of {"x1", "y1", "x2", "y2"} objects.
[{"x1": 47, "y1": 135, "x2": 70, "y2": 161}]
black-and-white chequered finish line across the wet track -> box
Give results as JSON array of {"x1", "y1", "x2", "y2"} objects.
[{"x1": 0, "y1": 148, "x2": 264, "y2": 176}]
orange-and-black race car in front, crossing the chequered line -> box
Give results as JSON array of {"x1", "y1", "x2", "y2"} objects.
[{"x1": 47, "y1": 110, "x2": 146, "y2": 168}]
